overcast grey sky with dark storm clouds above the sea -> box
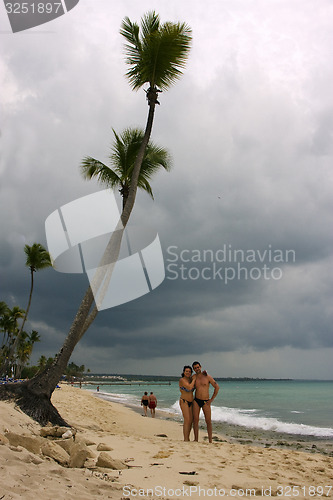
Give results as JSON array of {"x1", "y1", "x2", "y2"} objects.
[{"x1": 0, "y1": 0, "x2": 333, "y2": 379}]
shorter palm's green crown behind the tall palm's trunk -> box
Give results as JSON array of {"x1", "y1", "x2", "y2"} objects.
[{"x1": 81, "y1": 128, "x2": 171, "y2": 208}]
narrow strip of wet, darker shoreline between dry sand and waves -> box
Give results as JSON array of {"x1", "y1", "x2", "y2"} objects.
[{"x1": 92, "y1": 389, "x2": 333, "y2": 457}]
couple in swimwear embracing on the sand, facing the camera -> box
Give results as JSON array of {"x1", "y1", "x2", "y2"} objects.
[{"x1": 179, "y1": 361, "x2": 220, "y2": 443}]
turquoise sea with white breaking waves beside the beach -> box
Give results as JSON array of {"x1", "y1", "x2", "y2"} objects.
[{"x1": 81, "y1": 375, "x2": 333, "y2": 439}]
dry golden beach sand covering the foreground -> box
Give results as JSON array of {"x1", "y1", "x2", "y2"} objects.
[{"x1": 0, "y1": 384, "x2": 333, "y2": 500}]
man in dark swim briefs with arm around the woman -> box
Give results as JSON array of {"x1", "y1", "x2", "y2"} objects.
[{"x1": 192, "y1": 361, "x2": 220, "y2": 443}]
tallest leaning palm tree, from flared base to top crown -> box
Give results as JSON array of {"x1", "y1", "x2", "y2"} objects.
[{"x1": 0, "y1": 12, "x2": 192, "y2": 425}]
